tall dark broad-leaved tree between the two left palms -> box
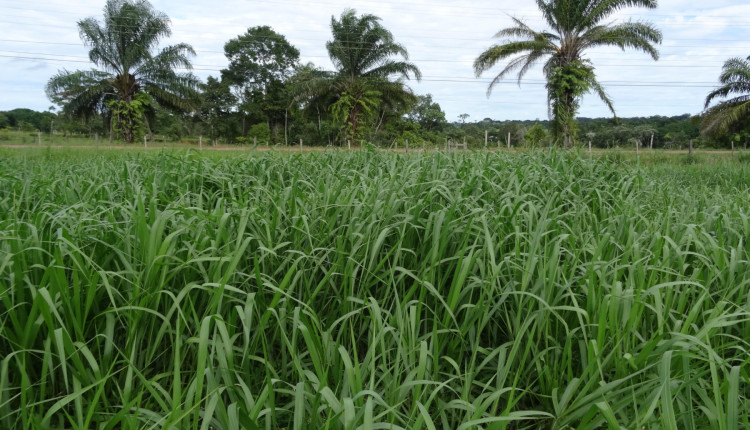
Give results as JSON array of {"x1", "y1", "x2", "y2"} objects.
[{"x1": 221, "y1": 25, "x2": 299, "y2": 135}]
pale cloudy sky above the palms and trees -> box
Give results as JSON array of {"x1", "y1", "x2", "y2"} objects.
[{"x1": 0, "y1": 0, "x2": 750, "y2": 122}]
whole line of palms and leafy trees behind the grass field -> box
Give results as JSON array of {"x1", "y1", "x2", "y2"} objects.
[{"x1": 7, "y1": 0, "x2": 750, "y2": 148}]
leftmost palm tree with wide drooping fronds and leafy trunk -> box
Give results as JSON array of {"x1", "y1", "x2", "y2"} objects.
[{"x1": 46, "y1": 0, "x2": 199, "y2": 142}]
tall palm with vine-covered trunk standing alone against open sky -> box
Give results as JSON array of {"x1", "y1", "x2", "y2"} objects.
[{"x1": 474, "y1": 0, "x2": 662, "y2": 146}]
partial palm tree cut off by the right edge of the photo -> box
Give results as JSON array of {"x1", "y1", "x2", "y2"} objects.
[{"x1": 701, "y1": 57, "x2": 750, "y2": 135}]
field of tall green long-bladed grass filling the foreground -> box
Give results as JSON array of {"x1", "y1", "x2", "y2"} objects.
[{"x1": 0, "y1": 150, "x2": 750, "y2": 430}]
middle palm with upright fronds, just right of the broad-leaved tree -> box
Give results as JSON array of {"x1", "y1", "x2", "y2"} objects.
[{"x1": 297, "y1": 9, "x2": 422, "y2": 144}]
